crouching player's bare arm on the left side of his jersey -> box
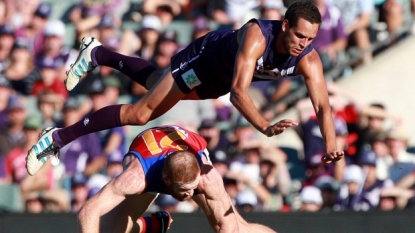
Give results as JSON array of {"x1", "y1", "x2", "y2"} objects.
[{"x1": 78, "y1": 156, "x2": 145, "y2": 233}]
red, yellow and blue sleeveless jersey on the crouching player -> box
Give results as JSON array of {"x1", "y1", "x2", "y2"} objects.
[{"x1": 128, "y1": 125, "x2": 207, "y2": 193}]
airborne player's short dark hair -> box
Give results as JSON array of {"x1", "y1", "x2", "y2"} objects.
[{"x1": 284, "y1": 0, "x2": 321, "y2": 27}]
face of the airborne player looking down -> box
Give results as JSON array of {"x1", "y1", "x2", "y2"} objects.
[{"x1": 282, "y1": 18, "x2": 319, "y2": 57}]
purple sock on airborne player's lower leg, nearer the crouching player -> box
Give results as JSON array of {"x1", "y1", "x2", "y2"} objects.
[{"x1": 52, "y1": 104, "x2": 122, "y2": 148}]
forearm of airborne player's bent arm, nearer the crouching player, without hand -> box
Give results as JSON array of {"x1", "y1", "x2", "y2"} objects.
[{"x1": 230, "y1": 90, "x2": 270, "y2": 133}]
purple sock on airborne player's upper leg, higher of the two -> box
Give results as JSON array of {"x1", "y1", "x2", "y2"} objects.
[{"x1": 91, "y1": 46, "x2": 157, "y2": 87}]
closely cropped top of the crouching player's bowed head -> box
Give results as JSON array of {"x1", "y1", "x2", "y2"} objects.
[{"x1": 163, "y1": 151, "x2": 200, "y2": 184}]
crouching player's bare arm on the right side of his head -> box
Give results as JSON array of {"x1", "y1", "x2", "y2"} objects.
[{"x1": 193, "y1": 157, "x2": 242, "y2": 233}]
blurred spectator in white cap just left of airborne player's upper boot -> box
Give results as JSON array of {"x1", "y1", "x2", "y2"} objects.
[{"x1": 35, "y1": 20, "x2": 78, "y2": 81}]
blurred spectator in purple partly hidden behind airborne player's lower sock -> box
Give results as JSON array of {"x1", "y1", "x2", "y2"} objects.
[{"x1": 60, "y1": 97, "x2": 105, "y2": 178}]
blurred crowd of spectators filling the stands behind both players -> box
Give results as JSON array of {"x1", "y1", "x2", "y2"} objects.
[{"x1": 0, "y1": 0, "x2": 415, "y2": 213}]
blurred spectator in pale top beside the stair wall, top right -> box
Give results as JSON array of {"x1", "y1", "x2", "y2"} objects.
[{"x1": 329, "y1": 0, "x2": 374, "y2": 63}]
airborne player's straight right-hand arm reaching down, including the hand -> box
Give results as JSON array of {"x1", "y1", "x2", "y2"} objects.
[{"x1": 298, "y1": 50, "x2": 344, "y2": 163}]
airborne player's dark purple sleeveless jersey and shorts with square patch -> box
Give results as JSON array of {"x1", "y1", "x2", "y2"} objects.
[{"x1": 171, "y1": 19, "x2": 313, "y2": 99}]
